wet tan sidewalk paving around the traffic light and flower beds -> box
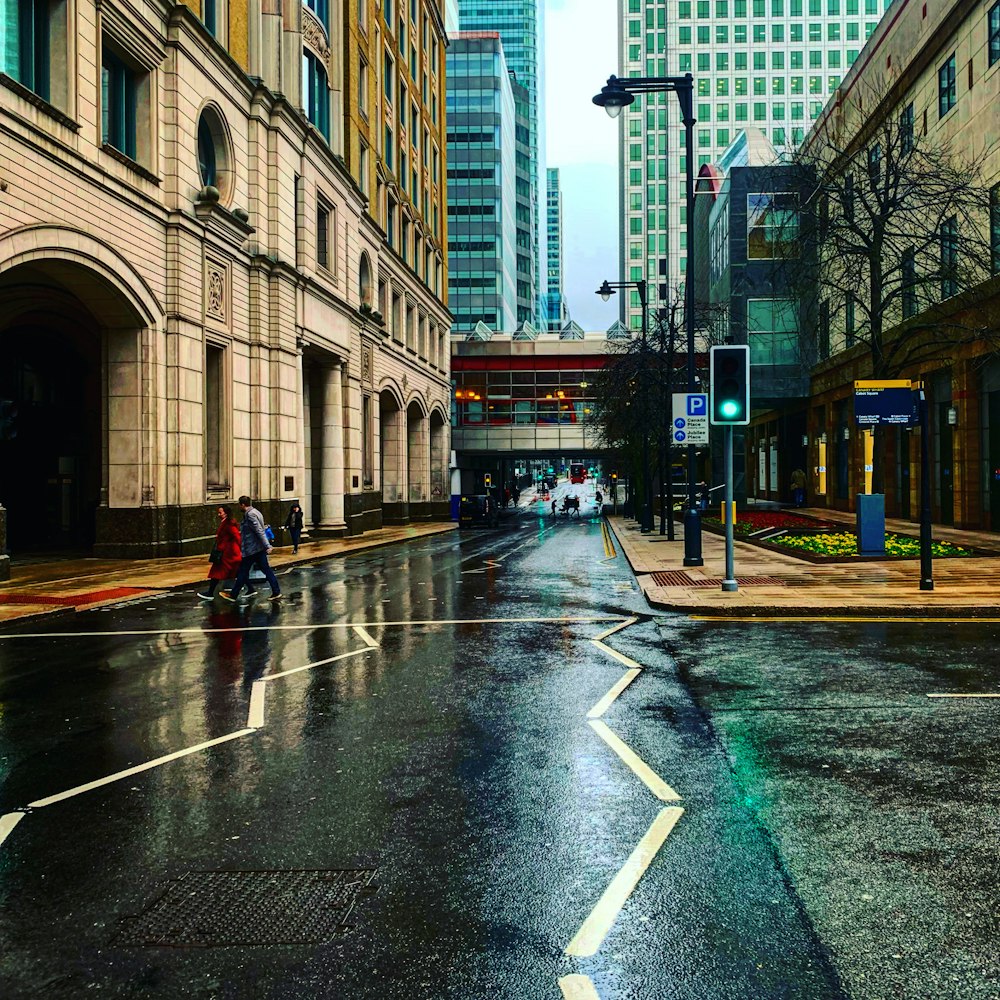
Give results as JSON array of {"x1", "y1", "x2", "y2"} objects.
[{"x1": 607, "y1": 509, "x2": 1000, "y2": 618}]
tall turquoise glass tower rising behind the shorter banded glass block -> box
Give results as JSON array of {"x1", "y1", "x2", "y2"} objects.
[{"x1": 458, "y1": 0, "x2": 545, "y2": 325}]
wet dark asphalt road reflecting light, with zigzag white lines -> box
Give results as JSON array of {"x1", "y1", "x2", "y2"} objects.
[{"x1": 0, "y1": 487, "x2": 1000, "y2": 1000}]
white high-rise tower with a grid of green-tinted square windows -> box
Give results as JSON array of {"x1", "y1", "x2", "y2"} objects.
[{"x1": 618, "y1": 0, "x2": 890, "y2": 329}]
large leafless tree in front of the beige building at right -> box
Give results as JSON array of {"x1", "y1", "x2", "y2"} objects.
[{"x1": 778, "y1": 86, "x2": 997, "y2": 492}]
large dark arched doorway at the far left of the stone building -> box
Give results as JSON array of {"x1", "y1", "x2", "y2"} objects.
[{"x1": 0, "y1": 250, "x2": 148, "y2": 558}]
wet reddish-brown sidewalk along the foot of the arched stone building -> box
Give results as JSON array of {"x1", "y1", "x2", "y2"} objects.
[{"x1": 0, "y1": 521, "x2": 458, "y2": 623}]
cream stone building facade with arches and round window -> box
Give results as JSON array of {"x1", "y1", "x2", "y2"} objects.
[{"x1": 0, "y1": 0, "x2": 450, "y2": 557}]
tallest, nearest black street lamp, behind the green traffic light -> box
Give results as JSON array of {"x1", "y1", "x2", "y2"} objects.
[{"x1": 594, "y1": 73, "x2": 704, "y2": 566}]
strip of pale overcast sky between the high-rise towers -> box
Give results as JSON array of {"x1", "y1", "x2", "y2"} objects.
[{"x1": 542, "y1": 0, "x2": 618, "y2": 330}]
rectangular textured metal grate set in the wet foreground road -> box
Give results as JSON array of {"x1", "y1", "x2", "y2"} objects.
[{"x1": 113, "y1": 868, "x2": 376, "y2": 948}]
